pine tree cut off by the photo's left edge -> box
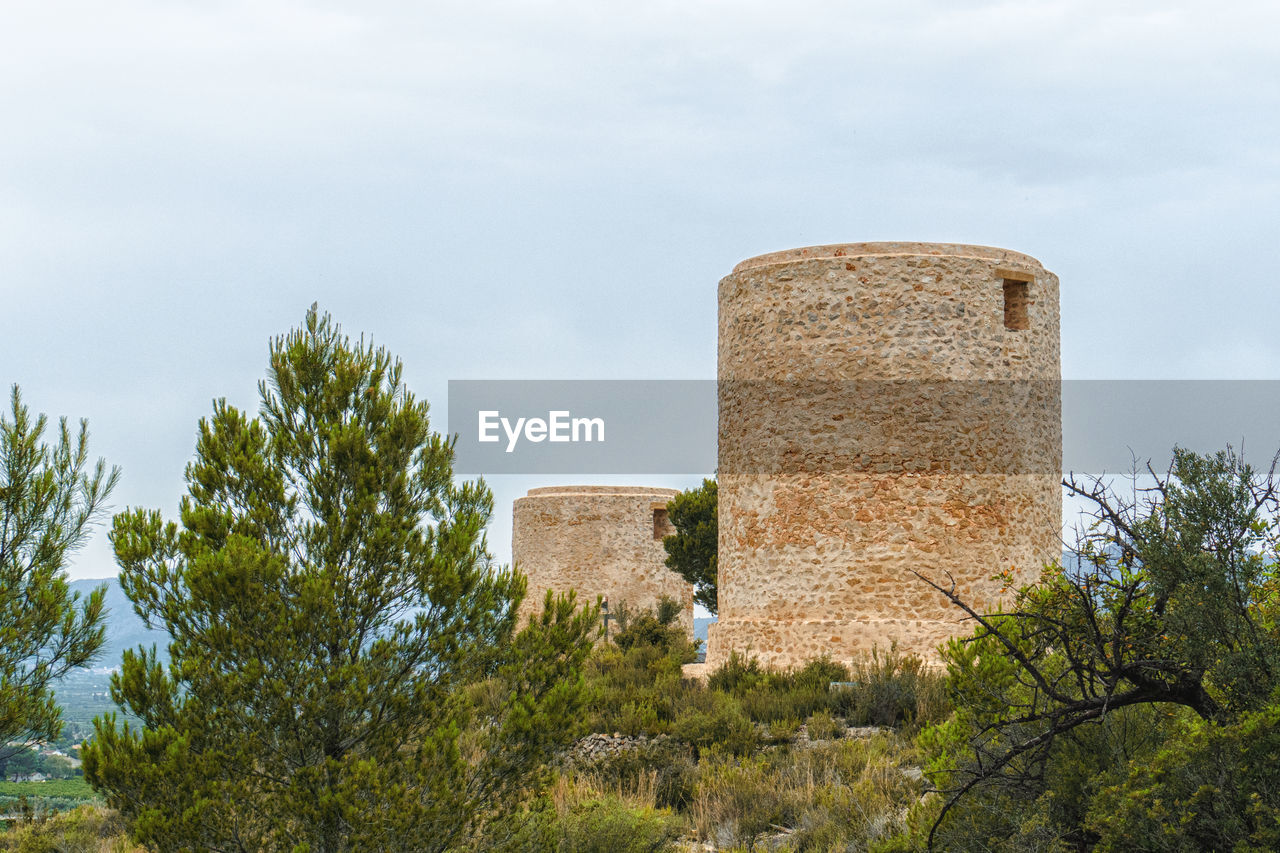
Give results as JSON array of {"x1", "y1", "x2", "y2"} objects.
[{"x1": 0, "y1": 386, "x2": 119, "y2": 758}]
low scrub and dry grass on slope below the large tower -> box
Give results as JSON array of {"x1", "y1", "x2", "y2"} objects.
[{"x1": 576, "y1": 601, "x2": 946, "y2": 850}]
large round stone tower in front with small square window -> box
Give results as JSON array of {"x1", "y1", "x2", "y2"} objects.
[{"x1": 707, "y1": 243, "x2": 1062, "y2": 667}]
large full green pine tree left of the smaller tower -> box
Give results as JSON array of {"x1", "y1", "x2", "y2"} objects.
[{"x1": 84, "y1": 307, "x2": 596, "y2": 853}]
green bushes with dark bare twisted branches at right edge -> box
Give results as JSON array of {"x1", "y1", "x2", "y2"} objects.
[{"x1": 919, "y1": 448, "x2": 1280, "y2": 850}]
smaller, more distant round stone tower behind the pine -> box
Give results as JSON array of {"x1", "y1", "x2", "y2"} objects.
[{"x1": 511, "y1": 485, "x2": 694, "y2": 635}]
